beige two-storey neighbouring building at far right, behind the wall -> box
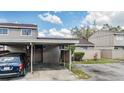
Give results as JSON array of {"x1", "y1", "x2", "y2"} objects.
[{"x1": 89, "y1": 30, "x2": 124, "y2": 59}]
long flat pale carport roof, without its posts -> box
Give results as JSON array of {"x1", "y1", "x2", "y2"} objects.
[{"x1": 0, "y1": 38, "x2": 79, "y2": 44}]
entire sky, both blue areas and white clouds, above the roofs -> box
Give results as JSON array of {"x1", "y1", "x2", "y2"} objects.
[{"x1": 0, "y1": 11, "x2": 124, "y2": 37}]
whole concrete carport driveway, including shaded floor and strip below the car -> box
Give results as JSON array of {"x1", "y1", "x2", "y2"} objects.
[{"x1": 1, "y1": 64, "x2": 77, "y2": 81}]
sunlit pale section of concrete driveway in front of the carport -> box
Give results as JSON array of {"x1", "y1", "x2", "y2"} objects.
[{"x1": 21, "y1": 69, "x2": 76, "y2": 81}]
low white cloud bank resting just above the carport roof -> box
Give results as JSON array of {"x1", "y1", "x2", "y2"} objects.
[{"x1": 38, "y1": 28, "x2": 72, "y2": 38}]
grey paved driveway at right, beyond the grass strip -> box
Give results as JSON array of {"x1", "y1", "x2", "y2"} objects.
[{"x1": 75, "y1": 63, "x2": 124, "y2": 81}]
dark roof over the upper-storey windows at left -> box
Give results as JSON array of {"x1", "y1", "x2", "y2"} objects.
[{"x1": 0, "y1": 23, "x2": 37, "y2": 30}]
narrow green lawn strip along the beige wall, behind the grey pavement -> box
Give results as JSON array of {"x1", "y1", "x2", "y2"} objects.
[{"x1": 74, "y1": 59, "x2": 117, "y2": 64}]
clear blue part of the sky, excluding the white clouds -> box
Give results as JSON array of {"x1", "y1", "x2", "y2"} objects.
[{"x1": 0, "y1": 11, "x2": 87, "y2": 31}]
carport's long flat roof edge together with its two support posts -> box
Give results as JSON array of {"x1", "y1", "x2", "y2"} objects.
[{"x1": 0, "y1": 38, "x2": 79, "y2": 73}]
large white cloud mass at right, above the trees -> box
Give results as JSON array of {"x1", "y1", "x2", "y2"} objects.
[{"x1": 82, "y1": 11, "x2": 124, "y2": 27}]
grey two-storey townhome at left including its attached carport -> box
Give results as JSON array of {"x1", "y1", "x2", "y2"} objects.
[{"x1": 0, "y1": 23, "x2": 79, "y2": 72}]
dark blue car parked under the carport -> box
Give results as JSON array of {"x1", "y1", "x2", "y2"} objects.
[{"x1": 0, "y1": 53, "x2": 26, "y2": 78}]
